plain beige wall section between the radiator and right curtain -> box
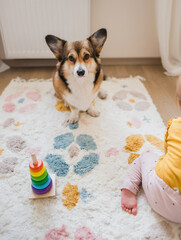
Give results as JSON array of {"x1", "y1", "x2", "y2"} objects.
[{"x1": 91, "y1": 0, "x2": 160, "y2": 58}]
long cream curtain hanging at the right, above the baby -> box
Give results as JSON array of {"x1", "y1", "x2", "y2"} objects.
[{"x1": 155, "y1": 0, "x2": 181, "y2": 76}]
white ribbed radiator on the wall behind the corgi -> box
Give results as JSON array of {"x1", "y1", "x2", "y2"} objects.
[{"x1": 0, "y1": 0, "x2": 90, "y2": 59}]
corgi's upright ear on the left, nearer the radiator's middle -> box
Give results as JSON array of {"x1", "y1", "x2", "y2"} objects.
[{"x1": 45, "y1": 35, "x2": 66, "y2": 61}]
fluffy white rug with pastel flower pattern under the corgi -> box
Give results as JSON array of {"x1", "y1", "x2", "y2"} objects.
[{"x1": 0, "y1": 77, "x2": 181, "y2": 240}]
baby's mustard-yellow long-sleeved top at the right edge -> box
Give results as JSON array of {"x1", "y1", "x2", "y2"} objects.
[{"x1": 155, "y1": 117, "x2": 181, "y2": 193}]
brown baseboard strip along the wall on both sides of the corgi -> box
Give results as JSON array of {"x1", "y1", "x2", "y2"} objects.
[{"x1": 3, "y1": 58, "x2": 161, "y2": 67}]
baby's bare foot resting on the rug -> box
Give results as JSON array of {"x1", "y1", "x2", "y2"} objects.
[{"x1": 121, "y1": 188, "x2": 137, "y2": 215}]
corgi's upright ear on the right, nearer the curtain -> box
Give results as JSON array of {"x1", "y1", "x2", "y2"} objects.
[{"x1": 88, "y1": 28, "x2": 107, "y2": 56}]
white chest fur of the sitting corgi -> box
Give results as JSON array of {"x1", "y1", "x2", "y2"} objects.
[{"x1": 65, "y1": 73, "x2": 97, "y2": 111}]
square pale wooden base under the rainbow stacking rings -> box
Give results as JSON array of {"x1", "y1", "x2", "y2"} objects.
[{"x1": 29, "y1": 174, "x2": 56, "y2": 199}]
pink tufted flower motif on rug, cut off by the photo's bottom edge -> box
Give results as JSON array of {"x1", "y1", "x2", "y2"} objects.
[{"x1": 44, "y1": 225, "x2": 107, "y2": 240}]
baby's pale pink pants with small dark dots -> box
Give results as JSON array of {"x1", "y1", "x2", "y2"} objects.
[{"x1": 121, "y1": 152, "x2": 181, "y2": 223}]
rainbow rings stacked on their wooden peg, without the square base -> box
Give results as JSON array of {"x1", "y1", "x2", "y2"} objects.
[{"x1": 29, "y1": 155, "x2": 52, "y2": 194}]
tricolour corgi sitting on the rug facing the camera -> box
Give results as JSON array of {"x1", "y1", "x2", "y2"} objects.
[{"x1": 45, "y1": 28, "x2": 107, "y2": 123}]
